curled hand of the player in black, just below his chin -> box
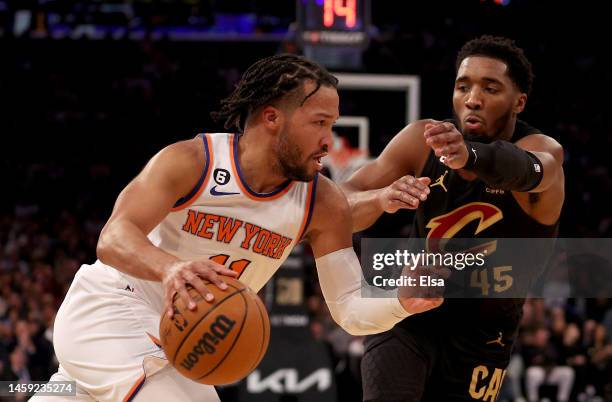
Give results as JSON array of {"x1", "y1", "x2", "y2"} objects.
[{"x1": 423, "y1": 121, "x2": 469, "y2": 169}]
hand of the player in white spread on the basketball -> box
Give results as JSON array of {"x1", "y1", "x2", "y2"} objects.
[{"x1": 162, "y1": 260, "x2": 238, "y2": 318}]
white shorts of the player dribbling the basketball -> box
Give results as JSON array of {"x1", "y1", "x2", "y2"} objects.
[{"x1": 32, "y1": 262, "x2": 219, "y2": 402}]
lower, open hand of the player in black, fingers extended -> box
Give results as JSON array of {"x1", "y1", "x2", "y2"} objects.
[{"x1": 378, "y1": 175, "x2": 431, "y2": 214}]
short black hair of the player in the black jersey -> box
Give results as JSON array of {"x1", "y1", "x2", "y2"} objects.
[{"x1": 455, "y1": 35, "x2": 533, "y2": 95}]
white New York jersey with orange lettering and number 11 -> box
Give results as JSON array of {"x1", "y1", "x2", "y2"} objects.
[{"x1": 109, "y1": 133, "x2": 317, "y2": 313}]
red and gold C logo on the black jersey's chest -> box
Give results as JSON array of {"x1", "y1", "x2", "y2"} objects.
[{"x1": 426, "y1": 202, "x2": 504, "y2": 252}]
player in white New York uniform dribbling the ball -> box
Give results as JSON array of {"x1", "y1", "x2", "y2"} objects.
[{"x1": 32, "y1": 55, "x2": 442, "y2": 402}]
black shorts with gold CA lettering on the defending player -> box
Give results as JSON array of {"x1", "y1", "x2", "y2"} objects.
[{"x1": 361, "y1": 326, "x2": 515, "y2": 402}]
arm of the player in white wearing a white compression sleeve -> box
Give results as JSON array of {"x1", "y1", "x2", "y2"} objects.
[{"x1": 306, "y1": 177, "x2": 442, "y2": 335}]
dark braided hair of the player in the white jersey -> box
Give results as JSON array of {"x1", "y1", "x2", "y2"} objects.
[{"x1": 211, "y1": 54, "x2": 338, "y2": 132}]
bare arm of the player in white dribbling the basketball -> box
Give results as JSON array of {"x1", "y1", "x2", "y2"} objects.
[{"x1": 96, "y1": 138, "x2": 235, "y2": 315}]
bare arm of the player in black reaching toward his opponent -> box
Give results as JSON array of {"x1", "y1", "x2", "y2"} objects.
[{"x1": 341, "y1": 120, "x2": 430, "y2": 232}]
